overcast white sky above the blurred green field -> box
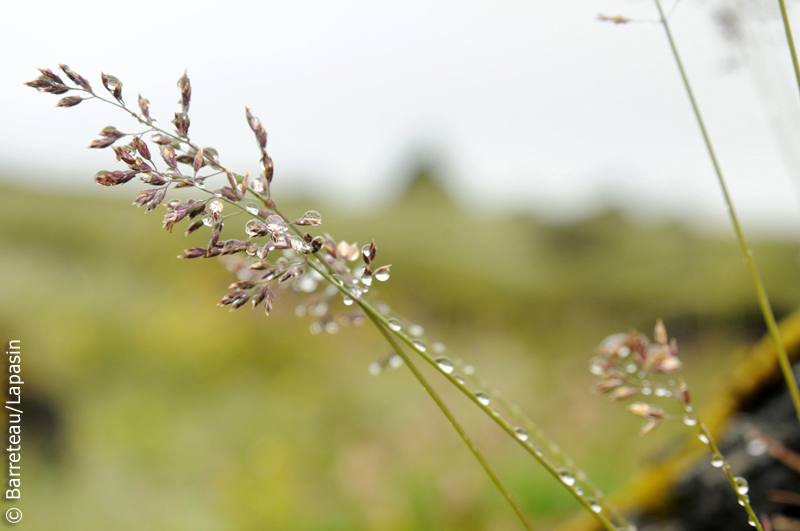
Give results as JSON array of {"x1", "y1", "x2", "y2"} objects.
[{"x1": 0, "y1": 0, "x2": 800, "y2": 238}]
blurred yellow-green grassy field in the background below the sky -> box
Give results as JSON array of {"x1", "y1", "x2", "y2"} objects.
[{"x1": 0, "y1": 170, "x2": 800, "y2": 531}]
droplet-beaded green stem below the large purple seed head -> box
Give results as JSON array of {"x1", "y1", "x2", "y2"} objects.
[{"x1": 308, "y1": 258, "x2": 618, "y2": 531}]
